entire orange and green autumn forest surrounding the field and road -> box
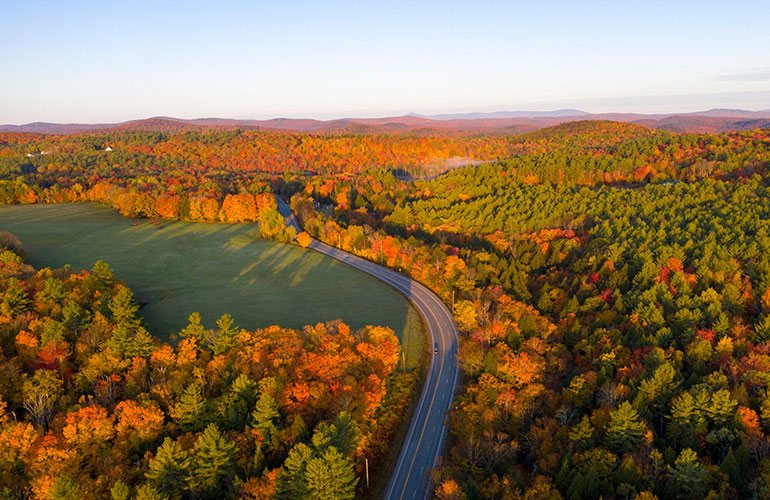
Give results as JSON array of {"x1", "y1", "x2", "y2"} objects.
[{"x1": 0, "y1": 122, "x2": 770, "y2": 500}]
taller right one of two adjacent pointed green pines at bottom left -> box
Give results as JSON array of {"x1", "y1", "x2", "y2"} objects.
[{"x1": 190, "y1": 424, "x2": 235, "y2": 498}]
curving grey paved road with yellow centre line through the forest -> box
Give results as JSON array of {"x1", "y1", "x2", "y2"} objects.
[{"x1": 276, "y1": 197, "x2": 459, "y2": 500}]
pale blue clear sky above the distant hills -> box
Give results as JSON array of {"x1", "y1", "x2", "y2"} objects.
[{"x1": 0, "y1": 0, "x2": 770, "y2": 123}]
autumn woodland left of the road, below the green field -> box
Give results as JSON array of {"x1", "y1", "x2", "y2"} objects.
[{"x1": 0, "y1": 233, "x2": 417, "y2": 500}]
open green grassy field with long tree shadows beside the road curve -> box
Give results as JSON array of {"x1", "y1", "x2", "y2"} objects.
[{"x1": 0, "y1": 204, "x2": 423, "y2": 368}]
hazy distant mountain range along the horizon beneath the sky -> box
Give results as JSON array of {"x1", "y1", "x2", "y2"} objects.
[{"x1": 0, "y1": 109, "x2": 770, "y2": 135}]
